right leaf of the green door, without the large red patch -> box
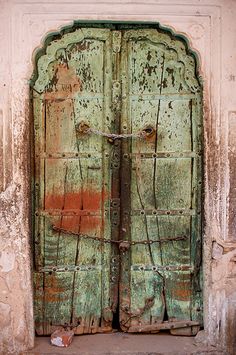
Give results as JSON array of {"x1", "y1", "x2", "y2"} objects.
[{"x1": 120, "y1": 29, "x2": 202, "y2": 335}]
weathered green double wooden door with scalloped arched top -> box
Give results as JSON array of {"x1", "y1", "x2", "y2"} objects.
[{"x1": 32, "y1": 25, "x2": 202, "y2": 334}]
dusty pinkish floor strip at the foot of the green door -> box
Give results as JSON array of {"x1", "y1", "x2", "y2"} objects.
[{"x1": 22, "y1": 333, "x2": 224, "y2": 355}]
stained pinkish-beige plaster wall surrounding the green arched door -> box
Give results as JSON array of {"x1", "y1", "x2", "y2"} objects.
[{"x1": 0, "y1": 0, "x2": 236, "y2": 354}]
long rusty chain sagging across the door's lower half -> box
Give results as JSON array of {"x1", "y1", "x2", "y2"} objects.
[{"x1": 52, "y1": 226, "x2": 187, "y2": 251}]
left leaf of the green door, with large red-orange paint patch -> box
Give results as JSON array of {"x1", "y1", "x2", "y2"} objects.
[{"x1": 32, "y1": 28, "x2": 114, "y2": 335}]
